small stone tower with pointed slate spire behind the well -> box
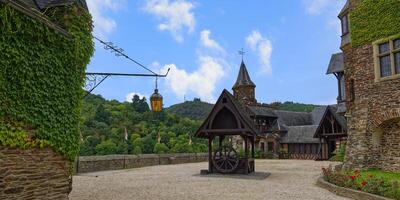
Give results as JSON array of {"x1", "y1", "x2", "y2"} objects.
[{"x1": 232, "y1": 60, "x2": 257, "y2": 105}]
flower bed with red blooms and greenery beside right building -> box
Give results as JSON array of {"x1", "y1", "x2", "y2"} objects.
[{"x1": 322, "y1": 167, "x2": 400, "y2": 200}]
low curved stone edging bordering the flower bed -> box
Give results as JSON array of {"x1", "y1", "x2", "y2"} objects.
[{"x1": 317, "y1": 176, "x2": 393, "y2": 200}]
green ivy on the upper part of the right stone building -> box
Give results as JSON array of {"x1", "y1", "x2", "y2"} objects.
[{"x1": 350, "y1": 0, "x2": 400, "y2": 47}]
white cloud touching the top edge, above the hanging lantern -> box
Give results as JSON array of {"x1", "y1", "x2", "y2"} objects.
[{"x1": 143, "y1": 0, "x2": 196, "y2": 42}]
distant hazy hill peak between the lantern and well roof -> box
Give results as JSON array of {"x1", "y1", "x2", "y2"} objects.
[{"x1": 166, "y1": 98, "x2": 214, "y2": 120}]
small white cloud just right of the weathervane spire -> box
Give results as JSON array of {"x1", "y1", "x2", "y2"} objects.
[{"x1": 246, "y1": 31, "x2": 272, "y2": 74}]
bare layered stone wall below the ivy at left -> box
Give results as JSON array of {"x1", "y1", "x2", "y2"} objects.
[{"x1": 0, "y1": 146, "x2": 72, "y2": 200}]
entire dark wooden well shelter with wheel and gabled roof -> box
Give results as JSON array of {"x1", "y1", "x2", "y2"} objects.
[{"x1": 195, "y1": 90, "x2": 259, "y2": 174}]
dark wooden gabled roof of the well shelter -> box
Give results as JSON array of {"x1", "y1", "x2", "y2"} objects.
[{"x1": 195, "y1": 89, "x2": 259, "y2": 138}]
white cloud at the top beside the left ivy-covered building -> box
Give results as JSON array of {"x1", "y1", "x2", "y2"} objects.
[{"x1": 86, "y1": 0, "x2": 124, "y2": 38}]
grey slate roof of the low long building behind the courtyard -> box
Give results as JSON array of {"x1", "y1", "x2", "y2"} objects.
[{"x1": 280, "y1": 125, "x2": 319, "y2": 144}]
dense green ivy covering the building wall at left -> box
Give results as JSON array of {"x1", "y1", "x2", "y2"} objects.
[{"x1": 0, "y1": 3, "x2": 94, "y2": 160}]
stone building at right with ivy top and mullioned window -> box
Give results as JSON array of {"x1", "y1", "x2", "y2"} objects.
[{"x1": 339, "y1": 0, "x2": 400, "y2": 171}]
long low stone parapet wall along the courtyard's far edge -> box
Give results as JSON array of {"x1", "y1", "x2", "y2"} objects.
[{"x1": 75, "y1": 153, "x2": 208, "y2": 173}]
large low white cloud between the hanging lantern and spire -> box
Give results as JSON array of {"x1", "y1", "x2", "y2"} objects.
[{"x1": 162, "y1": 56, "x2": 224, "y2": 102}]
